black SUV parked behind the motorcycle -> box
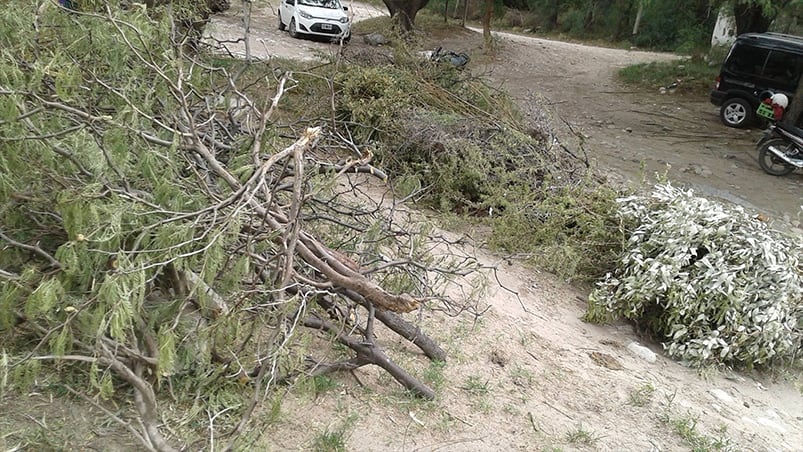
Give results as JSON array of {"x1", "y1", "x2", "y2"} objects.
[{"x1": 711, "y1": 33, "x2": 803, "y2": 127}]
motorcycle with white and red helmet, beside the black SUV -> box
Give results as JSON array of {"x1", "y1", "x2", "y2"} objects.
[{"x1": 756, "y1": 95, "x2": 803, "y2": 176}]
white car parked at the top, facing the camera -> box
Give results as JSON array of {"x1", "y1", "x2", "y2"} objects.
[{"x1": 279, "y1": 0, "x2": 351, "y2": 42}]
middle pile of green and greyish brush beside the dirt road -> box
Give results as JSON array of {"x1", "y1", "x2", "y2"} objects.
[{"x1": 336, "y1": 53, "x2": 622, "y2": 279}]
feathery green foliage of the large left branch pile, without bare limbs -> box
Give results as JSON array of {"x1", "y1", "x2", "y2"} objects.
[{"x1": 0, "y1": 1, "x2": 292, "y2": 444}]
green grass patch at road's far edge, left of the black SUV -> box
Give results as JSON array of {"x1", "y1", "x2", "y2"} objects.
[{"x1": 618, "y1": 57, "x2": 719, "y2": 97}]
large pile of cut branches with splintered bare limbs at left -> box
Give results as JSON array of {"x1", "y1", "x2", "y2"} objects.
[{"x1": 0, "y1": 1, "x2": 478, "y2": 450}]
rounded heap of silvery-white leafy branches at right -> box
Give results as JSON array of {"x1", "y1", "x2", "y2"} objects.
[{"x1": 586, "y1": 185, "x2": 803, "y2": 367}]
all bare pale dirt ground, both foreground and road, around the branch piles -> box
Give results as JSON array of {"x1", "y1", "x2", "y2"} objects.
[{"x1": 199, "y1": 3, "x2": 803, "y2": 451}]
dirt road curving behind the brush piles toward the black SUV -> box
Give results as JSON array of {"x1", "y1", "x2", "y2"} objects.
[{"x1": 478, "y1": 28, "x2": 803, "y2": 232}]
